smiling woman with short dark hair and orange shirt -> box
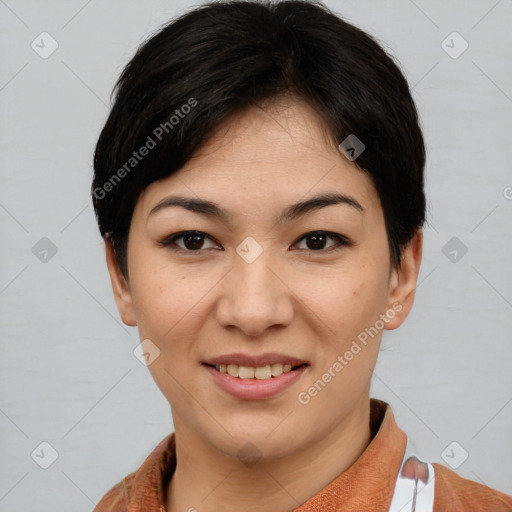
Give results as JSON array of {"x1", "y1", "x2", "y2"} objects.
[{"x1": 92, "y1": 0, "x2": 512, "y2": 512}]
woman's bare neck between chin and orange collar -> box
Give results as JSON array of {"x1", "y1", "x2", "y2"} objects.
[{"x1": 165, "y1": 400, "x2": 371, "y2": 512}]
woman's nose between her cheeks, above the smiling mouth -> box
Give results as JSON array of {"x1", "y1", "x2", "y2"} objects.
[{"x1": 216, "y1": 250, "x2": 294, "y2": 337}]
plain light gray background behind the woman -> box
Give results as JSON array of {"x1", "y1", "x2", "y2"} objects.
[{"x1": 0, "y1": 0, "x2": 512, "y2": 512}]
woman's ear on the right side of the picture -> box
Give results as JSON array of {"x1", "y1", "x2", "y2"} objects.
[{"x1": 385, "y1": 228, "x2": 423, "y2": 330}]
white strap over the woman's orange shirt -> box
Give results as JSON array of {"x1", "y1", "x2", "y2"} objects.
[{"x1": 389, "y1": 441, "x2": 436, "y2": 512}]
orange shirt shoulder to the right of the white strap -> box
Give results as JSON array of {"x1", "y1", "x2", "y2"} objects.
[{"x1": 433, "y1": 463, "x2": 512, "y2": 512}]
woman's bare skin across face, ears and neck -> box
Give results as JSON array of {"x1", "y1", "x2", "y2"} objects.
[{"x1": 106, "y1": 99, "x2": 422, "y2": 512}]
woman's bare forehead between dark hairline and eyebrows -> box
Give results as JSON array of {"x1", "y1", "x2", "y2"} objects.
[{"x1": 134, "y1": 101, "x2": 380, "y2": 222}]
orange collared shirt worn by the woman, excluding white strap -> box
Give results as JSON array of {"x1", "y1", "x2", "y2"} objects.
[{"x1": 93, "y1": 398, "x2": 512, "y2": 512}]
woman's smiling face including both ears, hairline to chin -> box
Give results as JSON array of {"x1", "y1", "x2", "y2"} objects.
[{"x1": 107, "y1": 96, "x2": 421, "y2": 459}]
